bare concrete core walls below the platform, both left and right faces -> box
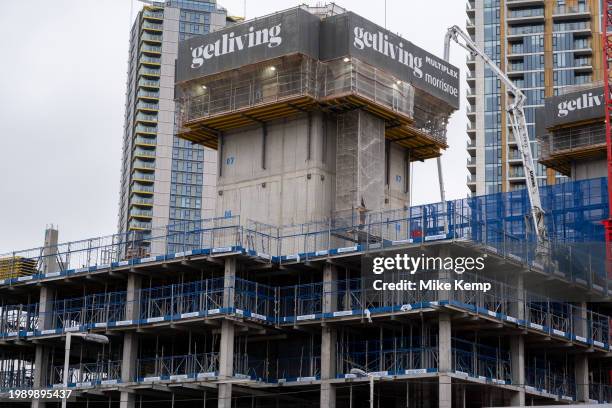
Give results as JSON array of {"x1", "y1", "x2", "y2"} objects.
[{"x1": 215, "y1": 112, "x2": 409, "y2": 225}]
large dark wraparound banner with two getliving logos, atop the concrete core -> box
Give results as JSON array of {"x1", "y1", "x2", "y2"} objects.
[{"x1": 176, "y1": 8, "x2": 459, "y2": 109}]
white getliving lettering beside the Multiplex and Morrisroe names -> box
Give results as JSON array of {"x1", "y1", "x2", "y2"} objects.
[{"x1": 353, "y1": 27, "x2": 423, "y2": 78}]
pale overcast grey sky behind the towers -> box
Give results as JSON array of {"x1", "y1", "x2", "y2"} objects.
[{"x1": 0, "y1": 0, "x2": 467, "y2": 253}]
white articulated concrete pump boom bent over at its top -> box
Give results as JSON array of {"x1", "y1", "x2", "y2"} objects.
[{"x1": 444, "y1": 26, "x2": 548, "y2": 249}]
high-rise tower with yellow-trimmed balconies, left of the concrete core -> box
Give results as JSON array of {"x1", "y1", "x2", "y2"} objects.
[{"x1": 118, "y1": 0, "x2": 227, "y2": 253}]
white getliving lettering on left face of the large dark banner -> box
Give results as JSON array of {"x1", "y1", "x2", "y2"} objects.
[{"x1": 191, "y1": 24, "x2": 283, "y2": 69}]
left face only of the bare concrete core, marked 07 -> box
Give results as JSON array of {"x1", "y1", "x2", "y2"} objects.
[{"x1": 216, "y1": 112, "x2": 335, "y2": 225}]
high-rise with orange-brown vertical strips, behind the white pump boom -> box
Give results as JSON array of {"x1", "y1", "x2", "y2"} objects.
[{"x1": 467, "y1": 0, "x2": 602, "y2": 195}]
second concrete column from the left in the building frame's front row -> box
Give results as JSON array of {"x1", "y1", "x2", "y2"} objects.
[{"x1": 119, "y1": 273, "x2": 142, "y2": 408}]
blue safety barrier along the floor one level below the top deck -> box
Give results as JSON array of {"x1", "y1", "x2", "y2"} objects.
[{"x1": 0, "y1": 272, "x2": 612, "y2": 350}]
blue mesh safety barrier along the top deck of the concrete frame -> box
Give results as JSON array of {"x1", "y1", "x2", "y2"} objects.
[{"x1": 0, "y1": 178, "x2": 608, "y2": 290}]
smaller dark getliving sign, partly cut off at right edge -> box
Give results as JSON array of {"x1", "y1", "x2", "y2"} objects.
[{"x1": 545, "y1": 87, "x2": 605, "y2": 128}]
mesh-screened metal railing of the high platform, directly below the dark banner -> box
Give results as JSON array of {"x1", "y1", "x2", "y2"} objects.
[{"x1": 177, "y1": 53, "x2": 426, "y2": 138}]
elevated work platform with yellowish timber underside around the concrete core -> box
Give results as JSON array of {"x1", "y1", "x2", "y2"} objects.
[{"x1": 178, "y1": 55, "x2": 451, "y2": 160}]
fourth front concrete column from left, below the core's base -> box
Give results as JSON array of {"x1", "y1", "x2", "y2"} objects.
[{"x1": 320, "y1": 264, "x2": 338, "y2": 408}]
